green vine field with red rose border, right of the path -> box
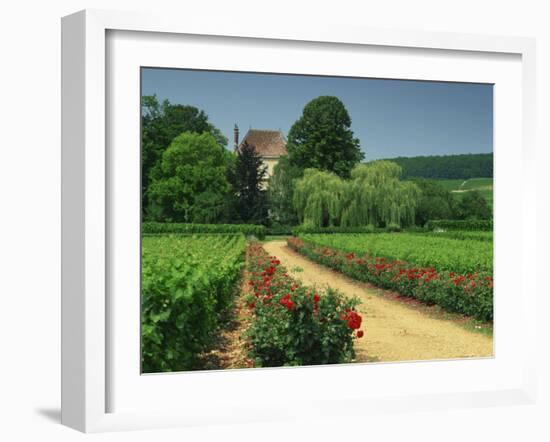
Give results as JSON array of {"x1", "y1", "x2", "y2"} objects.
[{"x1": 288, "y1": 234, "x2": 493, "y2": 321}]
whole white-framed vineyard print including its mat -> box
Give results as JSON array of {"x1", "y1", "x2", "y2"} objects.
[{"x1": 62, "y1": 11, "x2": 536, "y2": 431}]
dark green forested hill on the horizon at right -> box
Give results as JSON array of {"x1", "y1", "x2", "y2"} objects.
[{"x1": 376, "y1": 153, "x2": 493, "y2": 180}]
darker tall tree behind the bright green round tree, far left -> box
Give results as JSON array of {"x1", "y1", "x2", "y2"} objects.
[{"x1": 141, "y1": 96, "x2": 231, "y2": 215}]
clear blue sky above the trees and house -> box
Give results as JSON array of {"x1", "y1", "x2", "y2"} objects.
[{"x1": 142, "y1": 68, "x2": 493, "y2": 160}]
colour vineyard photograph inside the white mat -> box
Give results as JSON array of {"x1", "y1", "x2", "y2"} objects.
[{"x1": 136, "y1": 67, "x2": 495, "y2": 374}]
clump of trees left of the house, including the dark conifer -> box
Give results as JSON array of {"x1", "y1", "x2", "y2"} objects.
[{"x1": 141, "y1": 96, "x2": 267, "y2": 224}]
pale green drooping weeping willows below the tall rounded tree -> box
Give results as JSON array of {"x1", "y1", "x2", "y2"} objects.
[{"x1": 294, "y1": 161, "x2": 420, "y2": 227}]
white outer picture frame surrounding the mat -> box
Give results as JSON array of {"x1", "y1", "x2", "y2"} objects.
[{"x1": 62, "y1": 10, "x2": 536, "y2": 432}]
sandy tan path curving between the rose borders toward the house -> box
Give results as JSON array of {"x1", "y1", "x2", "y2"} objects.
[{"x1": 264, "y1": 241, "x2": 493, "y2": 361}]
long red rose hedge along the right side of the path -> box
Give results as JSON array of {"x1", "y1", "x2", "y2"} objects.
[{"x1": 288, "y1": 237, "x2": 493, "y2": 321}]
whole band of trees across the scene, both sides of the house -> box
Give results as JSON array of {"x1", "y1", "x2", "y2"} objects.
[{"x1": 142, "y1": 96, "x2": 491, "y2": 230}]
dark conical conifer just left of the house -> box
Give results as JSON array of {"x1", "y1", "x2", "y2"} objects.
[{"x1": 229, "y1": 142, "x2": 267, "y2": 224}]
